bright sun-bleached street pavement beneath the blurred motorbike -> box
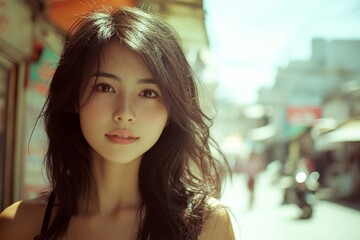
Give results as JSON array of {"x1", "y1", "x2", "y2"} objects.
[{"x1": 222, "y1": 172, "x2": 360, "y2": 240}]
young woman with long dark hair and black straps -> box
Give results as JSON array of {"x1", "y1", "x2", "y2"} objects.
[{"x1": 0, "y1": 8, "x2": 234, "y2": 240}]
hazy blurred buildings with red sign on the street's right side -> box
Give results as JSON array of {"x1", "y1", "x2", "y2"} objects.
[{"x1": 258, "y1": 39, "x2": 360, "y2": 201}]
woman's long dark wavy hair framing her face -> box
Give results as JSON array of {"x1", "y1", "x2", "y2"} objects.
[{"x1": 42, "y1": 8, "x2": 226, "y2": 240}]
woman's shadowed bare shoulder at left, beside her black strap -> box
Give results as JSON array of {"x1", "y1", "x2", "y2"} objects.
[{"x1": 0, "y1": 195, "x2": 48, "y2": 240}]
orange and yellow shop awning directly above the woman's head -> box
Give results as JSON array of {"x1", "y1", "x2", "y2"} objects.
[{"x1": 43, "y1": 0, "x2": 209, "y2": 50}]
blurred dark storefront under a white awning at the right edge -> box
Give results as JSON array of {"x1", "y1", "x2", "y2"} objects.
[{"x1": 315, "y1": 117, "x2": 360, "y2": 200}]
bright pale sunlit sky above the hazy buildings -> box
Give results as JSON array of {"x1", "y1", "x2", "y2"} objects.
[{"x1": 204, "y1": 0, "x2": 360, "y2": 104}]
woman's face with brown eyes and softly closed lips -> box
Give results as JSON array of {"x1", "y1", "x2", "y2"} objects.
[{"x1": 79, "y1": 41, "x2": 168, "y2": 163}]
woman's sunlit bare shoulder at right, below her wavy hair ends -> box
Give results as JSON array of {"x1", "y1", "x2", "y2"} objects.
[{"x1": 199, "y1": 199, "x2": 235, "y2": 240}]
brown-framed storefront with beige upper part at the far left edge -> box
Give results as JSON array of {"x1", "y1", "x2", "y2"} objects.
[{"x1": 0, "y1": 0, "x2": 33, "y2": 208}]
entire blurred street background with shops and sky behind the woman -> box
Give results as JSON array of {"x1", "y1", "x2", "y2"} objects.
[{"x1": 0, "y1": 0, "x2": 360, "y2": 240}]
